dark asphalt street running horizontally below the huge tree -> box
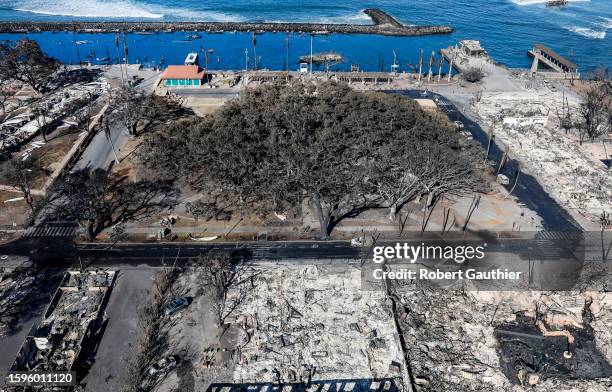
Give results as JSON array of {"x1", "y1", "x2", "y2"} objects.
[{"x1": 0, "y1": 232, "x2": 597, "y2": 265}]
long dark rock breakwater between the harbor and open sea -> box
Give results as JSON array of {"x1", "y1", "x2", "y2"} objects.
[{"x1": 0, "y1": 9, "x2": 454, "y2": 36}]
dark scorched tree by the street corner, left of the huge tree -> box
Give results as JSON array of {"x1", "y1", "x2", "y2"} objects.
[{"x1": 53, "y1": 170, "x2": 178, "y2": 241}]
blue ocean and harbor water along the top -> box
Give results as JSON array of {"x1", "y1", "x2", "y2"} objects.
[{"x1": 0, "y1": 0, "x2": 612, "y2": 72}]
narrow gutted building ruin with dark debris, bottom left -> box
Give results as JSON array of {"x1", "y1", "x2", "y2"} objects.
[{"x1": 11, "y1": 271, "x2": 115, "y2": 371}]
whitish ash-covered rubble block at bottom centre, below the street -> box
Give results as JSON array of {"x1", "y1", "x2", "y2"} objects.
[{"x1": 229, "y1": 265, "x2": 405, "y2": 390}]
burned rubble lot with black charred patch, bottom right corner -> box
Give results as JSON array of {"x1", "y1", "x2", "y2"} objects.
[{"x1": 395, "y1": 283, "x2": 612, "y2": 392}]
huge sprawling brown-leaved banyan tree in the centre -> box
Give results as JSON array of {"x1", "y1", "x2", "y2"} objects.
[{"x1": 141, "y1": 82, "x2": 483, "y2": 238}]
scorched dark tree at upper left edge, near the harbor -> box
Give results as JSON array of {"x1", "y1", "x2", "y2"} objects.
[{"x1": 0, "y1": 39, "x2": 59, "y2": 93}]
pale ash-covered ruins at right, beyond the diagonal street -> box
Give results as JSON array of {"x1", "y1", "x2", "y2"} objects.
[{"x1": 475, "y1": 91, "x2": 612, "y2": 222}]
